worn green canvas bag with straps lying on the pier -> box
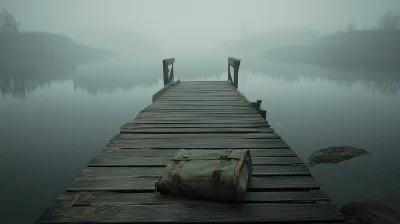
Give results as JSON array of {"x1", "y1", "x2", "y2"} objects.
[{"x1": 156, "y1": 149, "x2": 253, "y2": 202}]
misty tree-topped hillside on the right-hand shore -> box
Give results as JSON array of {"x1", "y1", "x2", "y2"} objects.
[{"x1": 264, "y1": 10, "x2": 400, "y2": 70}]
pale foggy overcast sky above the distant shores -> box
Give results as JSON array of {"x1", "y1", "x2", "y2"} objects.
[{"x1": 0, "y1": 0, "x2": 400, "y2": 53}]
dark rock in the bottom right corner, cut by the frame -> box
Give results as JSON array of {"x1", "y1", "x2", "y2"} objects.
[{"x1": 340, "y1": 201, "x2": 400, "y2": 224}]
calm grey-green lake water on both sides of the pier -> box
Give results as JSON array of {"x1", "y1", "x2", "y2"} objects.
[{"x1": 0, "y1": 59, "x2": 400, "y2": 223}]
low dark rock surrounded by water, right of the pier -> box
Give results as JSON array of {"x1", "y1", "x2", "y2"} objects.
[{"x1": 308, "y1": 146, "x2": 370, "y2": 166}]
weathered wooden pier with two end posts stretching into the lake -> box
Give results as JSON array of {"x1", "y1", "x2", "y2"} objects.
[{"x1": 37, "y1": 58, "x2": 344, "y2": 223}]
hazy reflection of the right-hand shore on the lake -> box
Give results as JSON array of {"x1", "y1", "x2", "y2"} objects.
[{"x1": 241, "y1": 60, "x2": 400, "y2": 97}]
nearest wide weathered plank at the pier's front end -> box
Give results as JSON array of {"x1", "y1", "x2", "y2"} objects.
[{"x1": 38, "y1": 203, "x2": 344, "y2": 223}]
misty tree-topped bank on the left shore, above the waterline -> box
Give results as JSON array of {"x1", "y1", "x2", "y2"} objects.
[{"x1": 0, "y1": 9, "x2": 112, "y2": 76}]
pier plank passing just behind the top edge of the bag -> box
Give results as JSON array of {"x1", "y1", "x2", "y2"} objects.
[{"x1": 103, "y1": 147, "x2": 297, "y2": 157}]
